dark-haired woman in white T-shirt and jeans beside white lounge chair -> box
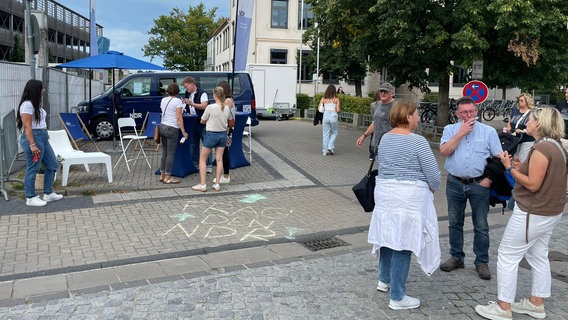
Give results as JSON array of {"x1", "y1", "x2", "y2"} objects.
[{"x1": 16, "y1": 79, "x2": 63, "y2": 207}]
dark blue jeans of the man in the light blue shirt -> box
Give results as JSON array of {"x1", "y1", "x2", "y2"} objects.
[{"x1": 446, "y1": 175, "x2": 489, "y2": 265}]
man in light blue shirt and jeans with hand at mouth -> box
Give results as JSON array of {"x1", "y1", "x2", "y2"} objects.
[{"x1": 440, "y1": 97, "x2": 503, "y2": 280}]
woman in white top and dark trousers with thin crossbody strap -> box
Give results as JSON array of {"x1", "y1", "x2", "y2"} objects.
[{"x1": 160, "y1": 83, "x2": 188, "y2": 184}]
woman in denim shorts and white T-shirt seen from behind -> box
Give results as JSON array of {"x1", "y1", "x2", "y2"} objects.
[{"x1": 191, "y1": 87, "x2": 235, "y2": 192}]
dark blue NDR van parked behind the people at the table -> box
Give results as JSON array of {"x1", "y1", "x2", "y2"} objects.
[{"x1": 77, "y1": 71, "x2": 258, "y2": 139}]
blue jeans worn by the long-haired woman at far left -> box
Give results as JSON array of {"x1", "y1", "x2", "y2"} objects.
[{"x1": 20, "y1": 129, "x2": 59, "y2": 198}]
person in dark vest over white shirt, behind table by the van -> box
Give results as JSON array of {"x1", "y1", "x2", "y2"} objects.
[{"x1": 181, "y1": 77, "x2": 212, "y2": 172}]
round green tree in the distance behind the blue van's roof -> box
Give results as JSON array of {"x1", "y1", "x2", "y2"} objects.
[{"x1": 142, "y1": 3, "x2": 226, "y2": 70}]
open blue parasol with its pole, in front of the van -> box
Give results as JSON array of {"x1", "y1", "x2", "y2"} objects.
[{"x1": 56, "y1": 51, "x2": 166, "y2": 150}]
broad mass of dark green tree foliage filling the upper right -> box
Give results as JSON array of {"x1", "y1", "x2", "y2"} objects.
[{"x1": 309, "y1": 0, "x2": 568, "y2": 125}]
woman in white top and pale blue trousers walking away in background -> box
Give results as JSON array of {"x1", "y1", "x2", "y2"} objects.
[{"x1": 319, "y1": 84, "x2": 341, "y2": 156}]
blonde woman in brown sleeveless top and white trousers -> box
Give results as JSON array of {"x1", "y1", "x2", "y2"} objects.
[{"x1": 475, "y1": 108, "x2": 567, "y2": 319}]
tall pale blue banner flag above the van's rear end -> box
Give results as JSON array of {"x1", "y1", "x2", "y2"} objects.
[{"x1": 233, "y1": 0, "x2": 254, "y2": 71}]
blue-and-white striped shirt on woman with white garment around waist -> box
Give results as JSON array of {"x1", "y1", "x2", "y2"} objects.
[{"x1": 377, "y1": 133, "x2": 441, "y2": 190}]
